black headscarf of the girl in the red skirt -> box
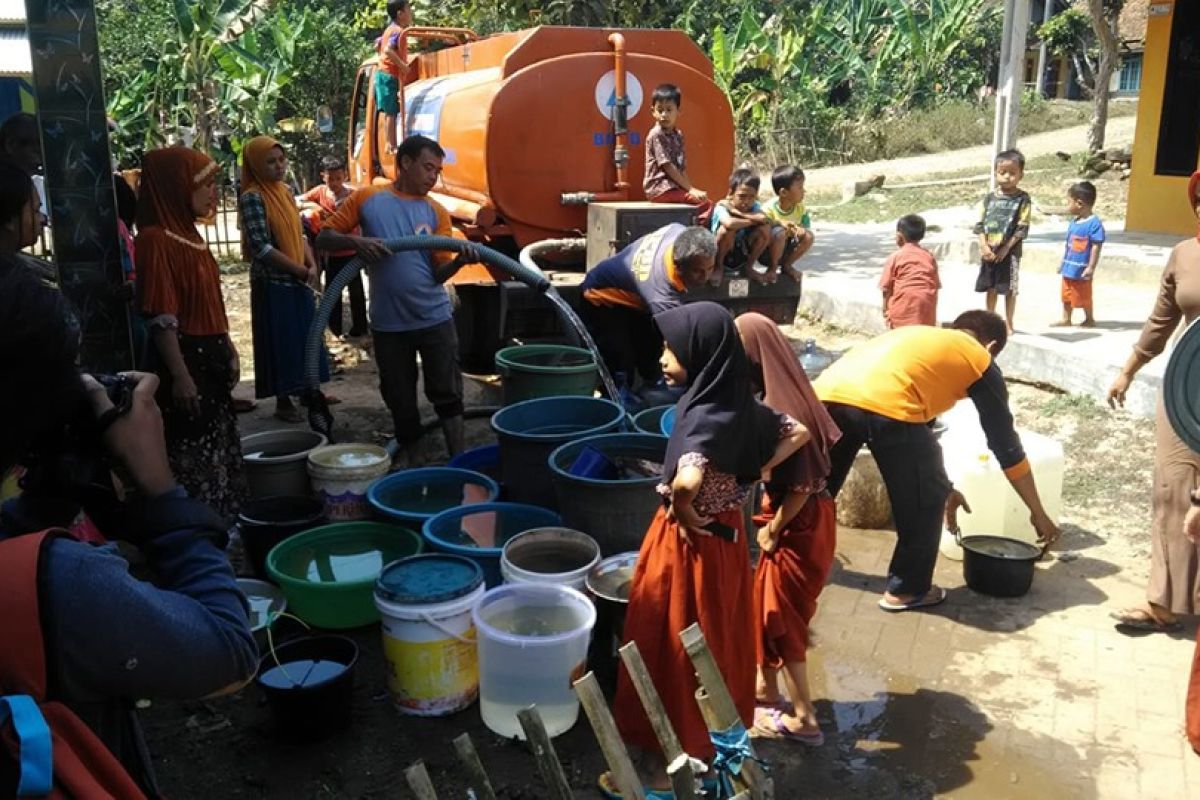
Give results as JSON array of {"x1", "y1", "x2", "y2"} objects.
[{"x1": 654, "y1": 302, "x2": 781, "y2": 483}]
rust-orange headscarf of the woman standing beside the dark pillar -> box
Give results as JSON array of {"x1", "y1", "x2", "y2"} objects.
[{"x1": 137, "y1": 148, "x2": 217, "y2": 237}]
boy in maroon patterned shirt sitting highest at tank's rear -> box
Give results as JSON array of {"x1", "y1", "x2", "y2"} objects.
[{"x1": 642, "y1": 83, "x2": 713, "y2": 225}]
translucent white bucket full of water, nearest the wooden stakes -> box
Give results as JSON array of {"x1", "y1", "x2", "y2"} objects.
[{"x1": 472, "y1": 583, "x2": 596, "y2": 739}]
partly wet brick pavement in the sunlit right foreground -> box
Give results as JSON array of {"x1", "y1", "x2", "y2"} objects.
[{"x1": 760, "y1": 529, "x2": 1200, "y2": 800}]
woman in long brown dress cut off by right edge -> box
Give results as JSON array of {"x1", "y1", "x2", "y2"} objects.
[{"x1": 1109, "y1": 172, "x2": 1200, "y2": 638}]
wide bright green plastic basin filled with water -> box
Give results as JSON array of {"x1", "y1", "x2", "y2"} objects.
[{"x1": 266, "y1": 522, "x2": 425, "y2": 628}]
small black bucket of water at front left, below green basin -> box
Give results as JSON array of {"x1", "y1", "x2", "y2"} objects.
[{"x1": 254, "y1": 636, "x2": 359, "y2": 741}]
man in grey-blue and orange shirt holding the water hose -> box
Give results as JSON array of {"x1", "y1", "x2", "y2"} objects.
[{"x1": 317, "y1": 136, "x2": 479, "y2": 467}]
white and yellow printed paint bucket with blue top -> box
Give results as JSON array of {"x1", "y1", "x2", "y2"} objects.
[{"x1": 374, "y1": 553, "x2": 486, "y2": 716}]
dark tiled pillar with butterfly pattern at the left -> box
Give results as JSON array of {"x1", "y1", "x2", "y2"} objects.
[{"x1": 25, "y1": 0, "x2": 133, "y2": 372}]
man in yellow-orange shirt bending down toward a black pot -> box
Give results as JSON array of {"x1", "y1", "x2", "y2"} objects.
[{"x1": 814, "y1": 311, "x2": 1058, "y2": 612}]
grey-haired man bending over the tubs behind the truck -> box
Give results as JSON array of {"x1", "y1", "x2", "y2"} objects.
[{"x1": 580, "y1": 223, "x2": 716, "y2": 398}]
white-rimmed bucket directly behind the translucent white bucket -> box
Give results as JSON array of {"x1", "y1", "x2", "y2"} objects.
[{"x1": 500, "y1": 528, "x2": 600, "y2": 591}]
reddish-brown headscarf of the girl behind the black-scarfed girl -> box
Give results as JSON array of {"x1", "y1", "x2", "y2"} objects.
[{"x1": 736, "y1": 312, "x2": 841, "y2": 489}]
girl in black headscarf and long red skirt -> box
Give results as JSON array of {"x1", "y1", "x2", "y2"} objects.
[{"x1": 600, "y1": 302, "x2": 808, "y2": 796}]
